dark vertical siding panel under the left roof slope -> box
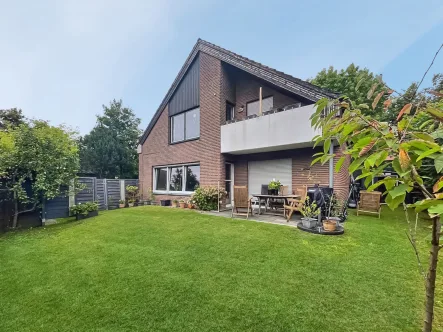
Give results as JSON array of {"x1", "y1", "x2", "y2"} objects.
[{"x1": 168, "y1": 56, "x2": 200, "y2": 116}]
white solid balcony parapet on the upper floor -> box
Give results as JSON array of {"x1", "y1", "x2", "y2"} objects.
[{"x1": 221, "y1": 105, "x2": 321, "y2": 154}]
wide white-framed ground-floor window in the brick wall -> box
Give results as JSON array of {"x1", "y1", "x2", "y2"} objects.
[{"x1": 154, "y1": 165, "x2": 200, "y2": 194}]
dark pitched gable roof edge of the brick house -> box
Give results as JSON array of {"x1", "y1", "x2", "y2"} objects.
[{"x1": 139, "y1": 38, "x2": 339, "y2": 144}]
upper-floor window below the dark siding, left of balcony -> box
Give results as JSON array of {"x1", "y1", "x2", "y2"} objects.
[{"x1": 171, "y1": 108, "x2": 200, "y2": 143}]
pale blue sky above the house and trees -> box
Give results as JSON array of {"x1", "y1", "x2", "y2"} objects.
[{"x1": 0, "y1": 0, "x2": 443, "y2": 134}]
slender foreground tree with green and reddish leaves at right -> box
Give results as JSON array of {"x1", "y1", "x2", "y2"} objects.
[{"x1": 311, "y1": 57, "x2": 443, "y2": 332}]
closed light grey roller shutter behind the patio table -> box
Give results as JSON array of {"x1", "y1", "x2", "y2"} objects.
[{"x1": 248, "y1": 159, "x2": 292, "y2": 196}]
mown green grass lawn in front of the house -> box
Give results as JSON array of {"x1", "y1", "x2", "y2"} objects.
[{"x1": 0, "y1": 207, "x2": 443, "y2": 332}]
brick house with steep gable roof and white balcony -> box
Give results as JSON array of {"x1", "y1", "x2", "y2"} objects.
[{"x1": 138, "y1": 39, "x2": 349, "y2": 203}]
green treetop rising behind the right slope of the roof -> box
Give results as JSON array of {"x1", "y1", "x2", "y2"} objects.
[{"x1": 310, "y1": 63, "x2": 385, "y2": 118}]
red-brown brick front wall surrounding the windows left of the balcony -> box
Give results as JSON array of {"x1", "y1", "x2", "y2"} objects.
[{"x1": 139, "y1": 53, "x2": 225, "y2": 200}]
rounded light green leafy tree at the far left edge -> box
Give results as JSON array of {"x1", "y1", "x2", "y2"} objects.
[{"x1": 0, "y1": 120, "x2": 79, "y2": 228}]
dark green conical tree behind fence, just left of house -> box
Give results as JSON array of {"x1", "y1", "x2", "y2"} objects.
[{"x1": 80, "y1": 100, "x2": 141, "y2": 178}]
